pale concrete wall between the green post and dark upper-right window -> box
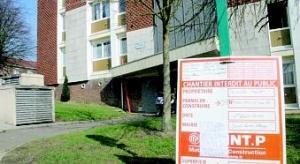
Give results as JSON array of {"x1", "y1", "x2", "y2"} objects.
[{"x1": 229, "y1": 2, "x2": 271, "y2": 56}]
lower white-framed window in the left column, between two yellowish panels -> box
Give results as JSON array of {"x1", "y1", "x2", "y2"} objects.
[{"x1": 93, "y1": 41, "x2": 111, "y2": 60}]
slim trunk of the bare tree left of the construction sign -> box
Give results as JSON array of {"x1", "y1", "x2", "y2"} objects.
[{"x1": 162, "y1": 22, "x2": 173, "y2": 132}]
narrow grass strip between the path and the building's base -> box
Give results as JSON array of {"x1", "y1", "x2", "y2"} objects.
[{"x1": 55, "y1": 102, "x2": 126, "y2": 121}]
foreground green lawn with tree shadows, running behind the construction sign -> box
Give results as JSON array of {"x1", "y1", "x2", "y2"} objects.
[{"x1": 3, "y1": 116, "x2": 300, "y2": 164}]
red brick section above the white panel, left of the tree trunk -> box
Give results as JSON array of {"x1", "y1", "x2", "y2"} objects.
[{"x1": 126, "y1": 0, "x2": 153, "y2": 32}]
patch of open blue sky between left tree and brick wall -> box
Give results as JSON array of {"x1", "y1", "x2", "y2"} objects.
[{"x1": 15, "y1": 0, "x2": 37, "y2": 61}]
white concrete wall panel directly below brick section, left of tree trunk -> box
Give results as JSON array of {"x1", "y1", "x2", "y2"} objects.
[{"x1": 127, "y1": 26, "x2": 154, "y2": 62}]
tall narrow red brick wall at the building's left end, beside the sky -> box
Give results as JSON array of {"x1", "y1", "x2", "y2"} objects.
[{"x1": 37, "y1": 0, "x2": 57, "y2": 85}]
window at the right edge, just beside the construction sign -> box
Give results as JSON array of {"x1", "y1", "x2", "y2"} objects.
[{"x1": 283, "y1": 61, "x2": 297, "y2": 104}]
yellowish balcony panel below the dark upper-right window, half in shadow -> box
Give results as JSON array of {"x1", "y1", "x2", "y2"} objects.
[{"x1": 269, "y1": 27, "x2": 293, "y2": 52}]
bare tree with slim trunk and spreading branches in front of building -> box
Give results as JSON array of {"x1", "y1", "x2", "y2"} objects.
[{"x1": 131, "y1": 0, "x2": 215, "y2": 132}]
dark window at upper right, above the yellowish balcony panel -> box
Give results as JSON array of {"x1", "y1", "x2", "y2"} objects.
[{"x1": 268, "y1": 2, "x2": 288, "y2": 29}]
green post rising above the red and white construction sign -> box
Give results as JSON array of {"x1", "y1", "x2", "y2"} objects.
[{"x1": 216, "y1": 0, "x2": 231, "y2": 56}]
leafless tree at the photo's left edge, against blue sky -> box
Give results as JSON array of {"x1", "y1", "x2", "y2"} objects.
[{"x1": 0, "y1": 0, "x2": 31, "y2": 70}]
